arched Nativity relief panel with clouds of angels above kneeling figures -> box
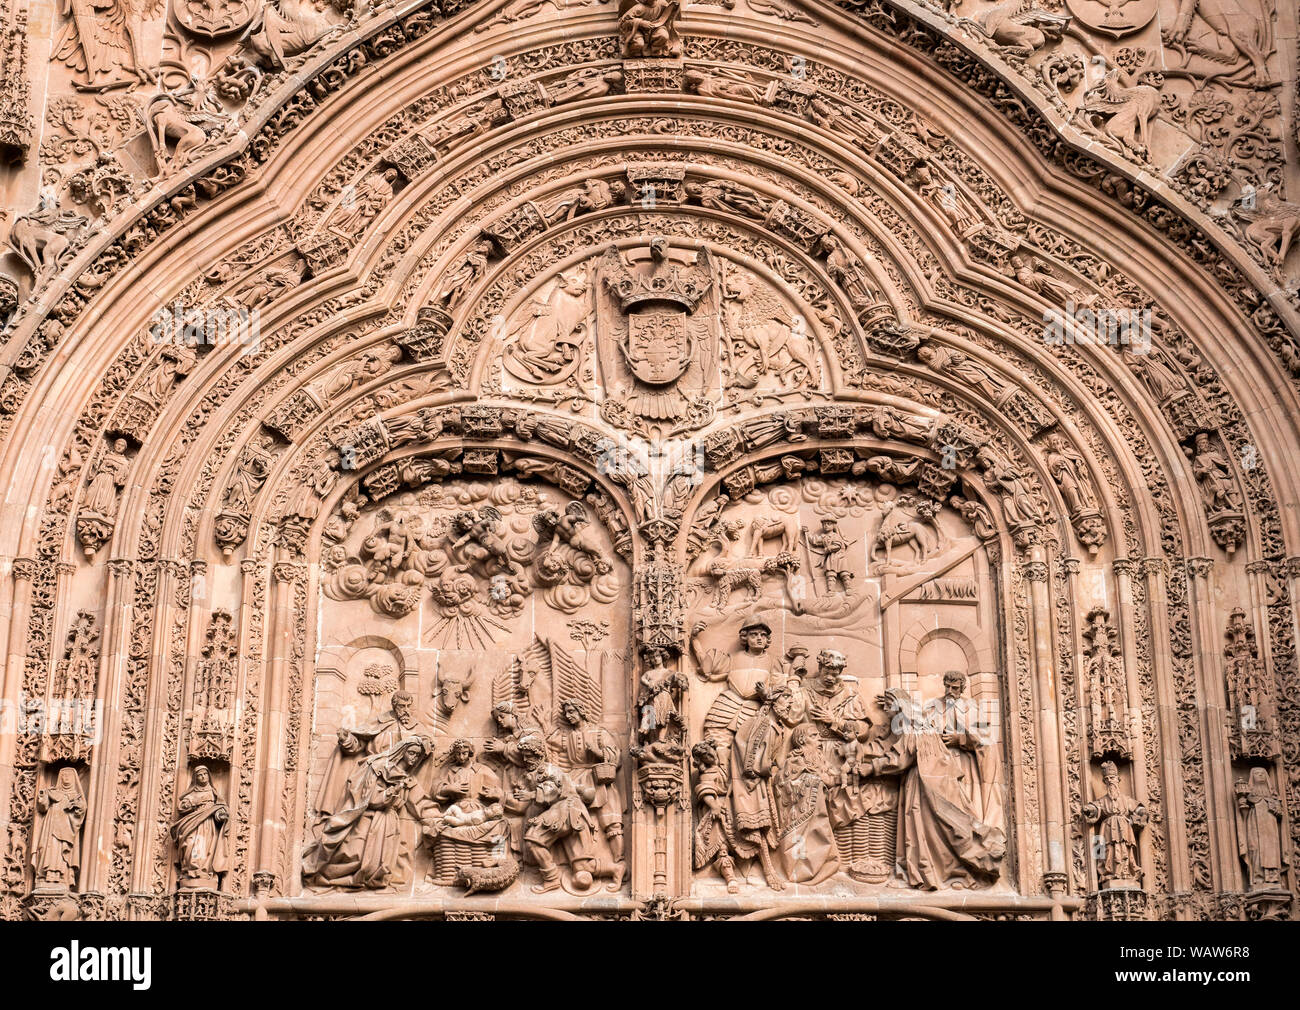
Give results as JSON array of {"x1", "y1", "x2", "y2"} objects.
[{"x1": 303, "y1": 475, "x2": 632, "y2": 894}]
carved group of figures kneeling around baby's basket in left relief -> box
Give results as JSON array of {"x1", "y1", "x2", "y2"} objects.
[{"x1": 303, "y1": 675, "x2": 627, "y2": 894}]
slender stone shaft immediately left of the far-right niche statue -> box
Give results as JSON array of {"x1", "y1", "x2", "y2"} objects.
[{"x1": 1187, "y1": 558, "x2": 1240, "y2": 890}]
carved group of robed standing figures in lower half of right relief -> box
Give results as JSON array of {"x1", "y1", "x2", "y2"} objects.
[{"x1": 692, "y1": 629, "x2": 1006, "y2": 892}]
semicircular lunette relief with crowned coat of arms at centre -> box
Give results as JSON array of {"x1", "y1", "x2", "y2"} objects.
[{"x1": 498, "y1": 236, "x2": 824, "y2": 439}]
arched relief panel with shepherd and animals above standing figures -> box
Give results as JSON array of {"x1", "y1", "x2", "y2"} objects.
[{"x1": 685, "y1": 473, "x2": 1006, "y2": 893}]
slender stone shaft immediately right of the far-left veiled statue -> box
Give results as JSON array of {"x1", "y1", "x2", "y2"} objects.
[{"x1": 79, "y1": 558, "x2": 139, "y2": 892}]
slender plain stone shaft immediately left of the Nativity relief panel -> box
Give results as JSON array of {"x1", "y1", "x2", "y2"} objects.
[{"x1": 252, "y1": 562, "x2": 306, "y2": 885}]
